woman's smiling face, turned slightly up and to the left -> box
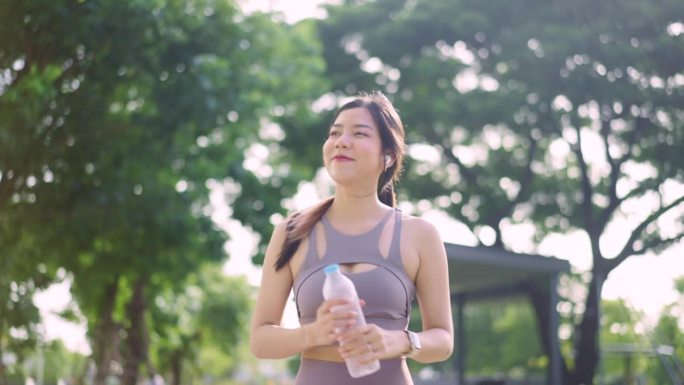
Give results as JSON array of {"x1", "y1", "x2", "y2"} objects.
[{"x1": 323, "y1": 107, "x2": 384, "y2": 189}]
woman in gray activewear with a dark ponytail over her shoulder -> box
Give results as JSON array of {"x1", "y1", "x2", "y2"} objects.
[{"x1": 250, "y1": 92, "x2": 453, "y2": 385}]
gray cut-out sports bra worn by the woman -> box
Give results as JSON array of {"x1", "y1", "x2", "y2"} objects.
[{"x1": 293, "y1": 209, "x2": 416, "y2": 330}]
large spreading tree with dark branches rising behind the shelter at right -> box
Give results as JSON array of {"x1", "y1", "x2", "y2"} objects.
[{"x1": 312, "y1": 0, "x2": 684, "y2": 384}]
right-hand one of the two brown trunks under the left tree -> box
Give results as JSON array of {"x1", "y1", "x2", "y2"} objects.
[{"x1": 121, "y1": 278, "x2": 147, "y2": 385}]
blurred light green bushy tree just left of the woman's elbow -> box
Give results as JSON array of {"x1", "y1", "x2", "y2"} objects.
[{"x1": 151, "y1": 265, "x2": 252, "y2": 385}]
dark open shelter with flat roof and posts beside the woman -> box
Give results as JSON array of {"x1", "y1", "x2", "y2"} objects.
[{"x1": 445, "y1": 243, "x2": 570, "y2": 385}]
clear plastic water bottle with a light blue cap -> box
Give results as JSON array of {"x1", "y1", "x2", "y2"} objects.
[{"x1": 323, "y1": 263, "x2": 380, "y2": 378}]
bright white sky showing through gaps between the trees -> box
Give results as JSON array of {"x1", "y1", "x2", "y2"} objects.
[{"x1": 29, "y1": 0, "x2": 684, "y2": 353}]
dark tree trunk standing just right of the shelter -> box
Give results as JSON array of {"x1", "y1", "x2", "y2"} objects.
[{"x1": 570, "y1": 268, "x2": 604, "y2": 385}]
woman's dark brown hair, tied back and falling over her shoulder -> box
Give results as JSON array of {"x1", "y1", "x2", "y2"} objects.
[{"x1": 275, "y1": 91, "x2": 406, "y2": 270}]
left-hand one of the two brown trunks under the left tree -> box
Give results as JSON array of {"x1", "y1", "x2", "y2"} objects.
[{"x1": 93, "y1": 277, "x2": 119, "y2": 385}]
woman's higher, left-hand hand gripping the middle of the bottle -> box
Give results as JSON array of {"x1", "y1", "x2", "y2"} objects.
[{"x1": 307, "y1": 299, "x2": 357, "y2": 346}]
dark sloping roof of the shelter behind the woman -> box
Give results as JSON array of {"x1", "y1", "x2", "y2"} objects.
[{"x1": 444, "y1": 243, "x2": 570, "y2": 294}]
